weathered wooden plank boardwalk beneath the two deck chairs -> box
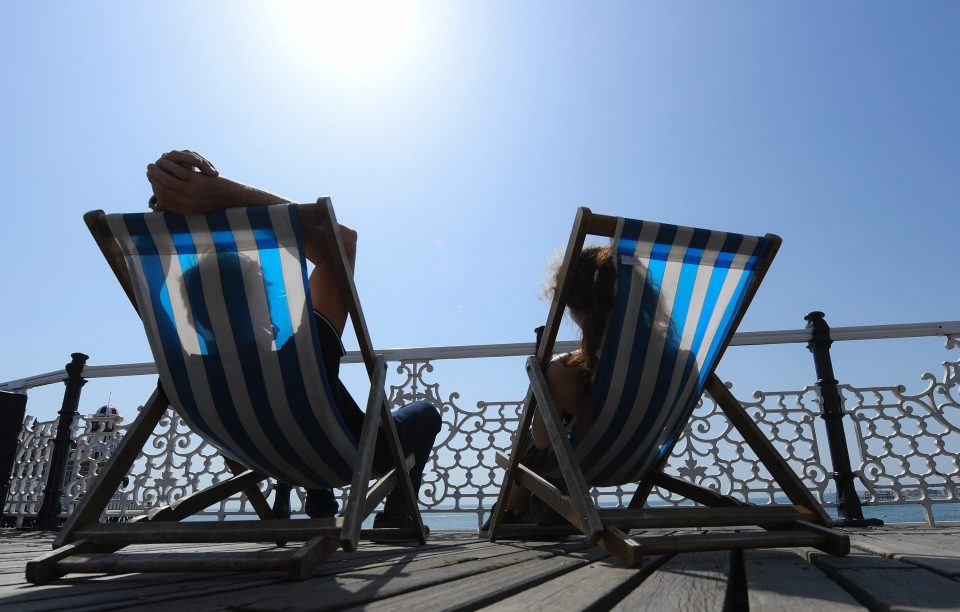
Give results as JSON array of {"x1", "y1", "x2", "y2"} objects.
[{"x1": 0, "y1": 525, "x2": 960, "y2": 612}]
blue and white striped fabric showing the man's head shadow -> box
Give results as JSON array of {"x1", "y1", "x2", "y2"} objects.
[{"x1": 107, "y1": 205, "x2": 357, "y2": 488}]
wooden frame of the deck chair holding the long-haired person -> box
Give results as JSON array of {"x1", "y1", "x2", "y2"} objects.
[{"x1": 486, "y1": 208, "x2": 850, "y2": 566}]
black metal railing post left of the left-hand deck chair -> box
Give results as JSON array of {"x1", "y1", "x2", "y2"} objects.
[{"x1": 37, "y1": 353, "x2": 89, "y2": 529}]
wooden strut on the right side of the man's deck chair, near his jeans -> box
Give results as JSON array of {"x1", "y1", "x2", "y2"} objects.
[{"x1": 340, "y1": 356, "x2": 387, "y2": 552}]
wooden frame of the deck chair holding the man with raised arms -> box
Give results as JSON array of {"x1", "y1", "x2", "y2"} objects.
[{"x1": 26, "y1": 197, "x2": 427, "y2": 584}]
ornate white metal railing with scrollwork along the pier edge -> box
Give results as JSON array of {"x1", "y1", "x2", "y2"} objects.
[{"x1": 0, "y1": 322, "x2": 960, "y2": 525}]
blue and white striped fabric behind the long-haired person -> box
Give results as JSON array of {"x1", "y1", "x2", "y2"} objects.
[{"x1": 574, "y1": 219, "x2": 772, "y2": 486}]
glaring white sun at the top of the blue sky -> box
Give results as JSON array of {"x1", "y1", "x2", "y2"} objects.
[{"x1": 264, "y1": 0, "x2": 424, "y2": 87}]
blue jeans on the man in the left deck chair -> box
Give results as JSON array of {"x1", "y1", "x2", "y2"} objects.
[{"x1": 305, "y1": 400, "x2": 442, "y2": 519}]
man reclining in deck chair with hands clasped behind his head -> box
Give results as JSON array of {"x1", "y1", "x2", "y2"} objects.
[{"x1": 147, "y1": 151, "x2": 441, "y2": 529}]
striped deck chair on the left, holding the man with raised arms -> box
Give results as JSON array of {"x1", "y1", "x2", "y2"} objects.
[{"x1": 27, "y1": 198, "x2": 426, "y2": 583}]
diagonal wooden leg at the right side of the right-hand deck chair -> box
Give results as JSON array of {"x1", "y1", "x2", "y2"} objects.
[{"x1": 706, "y1": 374, "x2": 833, "y2": 527}]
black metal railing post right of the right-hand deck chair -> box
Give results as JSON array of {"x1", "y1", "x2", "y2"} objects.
[{"x1": 804, "y1": 311, "x2": 883, "y2": 527}]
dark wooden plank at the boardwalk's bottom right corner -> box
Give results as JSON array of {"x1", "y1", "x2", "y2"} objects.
[{"x1": 809, "y1": 552, "x2": 960, "y2": 611}]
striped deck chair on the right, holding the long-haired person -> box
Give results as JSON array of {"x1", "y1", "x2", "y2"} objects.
[{"x1": 487, "y1": 208, "x2": 849, "y2": 565}]
